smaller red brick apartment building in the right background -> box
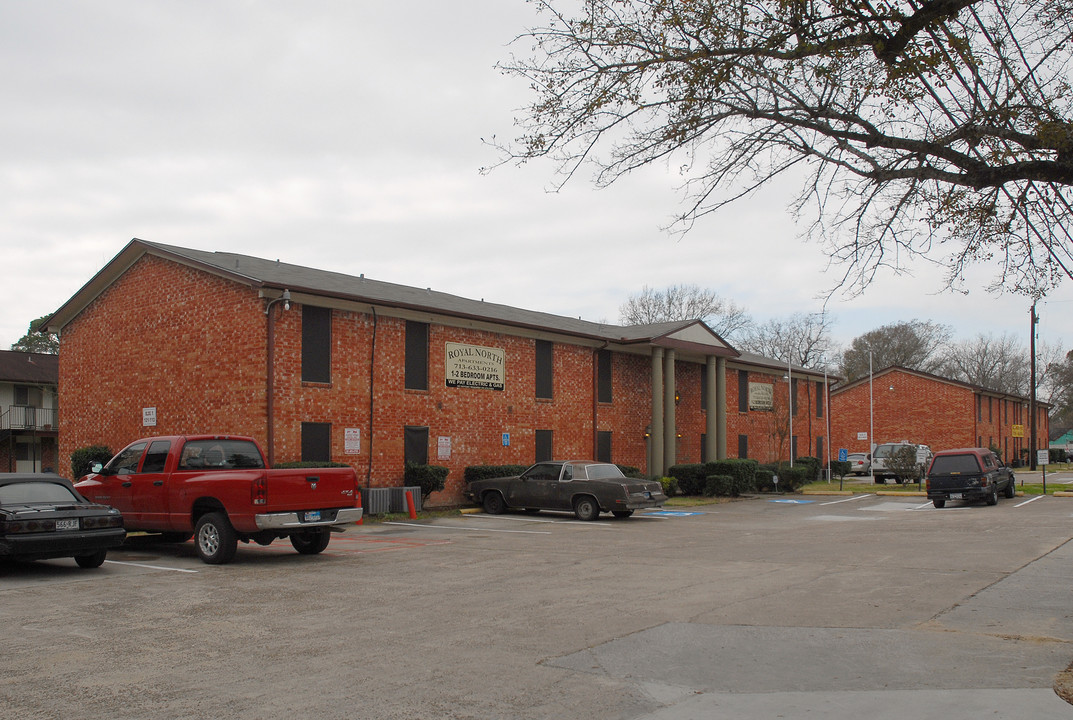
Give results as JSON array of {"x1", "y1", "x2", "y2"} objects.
[{"x1": 831, "y1": 367, "x2": 1049, "y2": 462}]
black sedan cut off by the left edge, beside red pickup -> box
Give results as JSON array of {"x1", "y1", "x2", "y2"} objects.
[{"x1": 0, "y1": 473, "x2": 127, "y2": 568}]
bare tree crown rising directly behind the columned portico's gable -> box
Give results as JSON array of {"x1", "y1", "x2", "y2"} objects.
[{"x1": 619, "y1": 284, "x2": 752, "y2": 340}]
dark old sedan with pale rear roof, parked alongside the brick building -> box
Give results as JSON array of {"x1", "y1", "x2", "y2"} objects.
[{"x1": 466, "y1": 460, "x2": 666, "y2": 520}]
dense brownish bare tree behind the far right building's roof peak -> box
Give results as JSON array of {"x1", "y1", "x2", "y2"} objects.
[{"x1": 840, "y1": 320, "x2": 953, "y2": 382}]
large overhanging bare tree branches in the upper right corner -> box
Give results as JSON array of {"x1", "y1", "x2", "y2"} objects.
[{"x1": 493, "y1": 0, "x2": 1073, "y2": 297}]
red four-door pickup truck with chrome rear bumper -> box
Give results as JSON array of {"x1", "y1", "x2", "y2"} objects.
[{"x1": 76, "y1": 435, "x2": 362, "y2": 564}]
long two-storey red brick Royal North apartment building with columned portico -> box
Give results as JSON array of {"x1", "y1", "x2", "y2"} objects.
[{"x1": 48, "y1": 239, "x2": 828, "y2": 504}]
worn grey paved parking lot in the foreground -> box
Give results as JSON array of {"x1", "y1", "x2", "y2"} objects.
[{"x1": 0, "y1": 495, "x2": 1073, "y2": 720}]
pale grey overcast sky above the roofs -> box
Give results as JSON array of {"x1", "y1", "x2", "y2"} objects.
[{"x1": 0, "y1": 0, "x2": 1073, "y2": 356}]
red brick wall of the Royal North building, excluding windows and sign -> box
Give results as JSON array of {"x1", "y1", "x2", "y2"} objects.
[{"x1": 54, "y1": 255, "x2": 824, "y2": 504}]
